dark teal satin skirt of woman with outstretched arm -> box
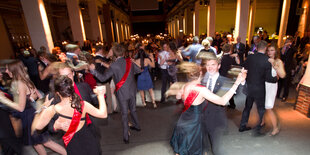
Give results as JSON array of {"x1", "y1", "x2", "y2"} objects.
[{"x1": 170, "y1": 104, "x2": 203, "y2": 155}]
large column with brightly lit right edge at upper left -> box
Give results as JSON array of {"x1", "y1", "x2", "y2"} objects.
[{"x1": 20, "y1": 0, "x2": 54, "y2": 52}]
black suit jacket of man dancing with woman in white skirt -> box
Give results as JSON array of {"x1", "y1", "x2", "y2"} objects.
[{"x1": 243, "y1": 52, "x2": 277, "y2": 98}]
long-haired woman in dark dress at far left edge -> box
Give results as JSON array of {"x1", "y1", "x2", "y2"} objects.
[{"x1": 0, "y1": 60, "x2": 66, "y2": 155}]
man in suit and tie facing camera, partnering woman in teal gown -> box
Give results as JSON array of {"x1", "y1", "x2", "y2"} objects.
[{"x1": 201, "y1": 52, "x2": 232, "y2": 155}]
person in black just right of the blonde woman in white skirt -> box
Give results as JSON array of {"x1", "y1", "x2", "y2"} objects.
[{"x1": 277, "y1": 37, "x2": 297, "y2": 102}]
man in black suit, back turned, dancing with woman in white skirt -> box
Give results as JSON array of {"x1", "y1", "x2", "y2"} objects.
[{"x1": 239, "y1": 41, "x2": 277, "y2": 136}]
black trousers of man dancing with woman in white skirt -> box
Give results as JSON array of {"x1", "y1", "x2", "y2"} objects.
[{"x1": 240, "y1": 95, "x2": 265, "y2": 130}]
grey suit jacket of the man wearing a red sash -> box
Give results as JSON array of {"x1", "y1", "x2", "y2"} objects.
[{"x1": 91, "y1": 57, "x2": 141, "y2": 100}]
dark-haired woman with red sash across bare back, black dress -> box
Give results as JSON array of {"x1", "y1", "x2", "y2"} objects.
[{"x1": 33, "y1": 76, "x2": 107, "y2": 155}]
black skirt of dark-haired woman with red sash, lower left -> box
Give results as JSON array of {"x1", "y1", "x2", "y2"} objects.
[{"x1": 66, "y1": 122, "x2": 101, "y2": 155}]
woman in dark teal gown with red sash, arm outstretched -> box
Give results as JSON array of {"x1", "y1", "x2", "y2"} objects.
[{"x1": 167, "y1": 62, "x2": 246, "y2": 155}]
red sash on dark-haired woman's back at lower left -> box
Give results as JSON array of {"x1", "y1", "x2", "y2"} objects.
[{"x1": 62, "y1": 100, "x2": 84, "y2": 147}]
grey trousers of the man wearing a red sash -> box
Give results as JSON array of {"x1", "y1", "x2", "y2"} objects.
[{"x1": 118, "y1": 96, "x2": 140, "y2": 140}]
